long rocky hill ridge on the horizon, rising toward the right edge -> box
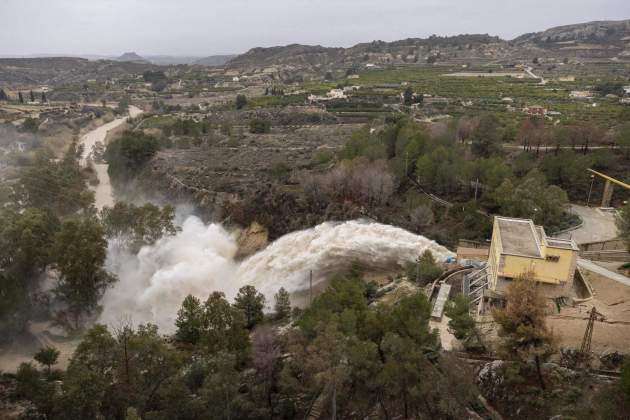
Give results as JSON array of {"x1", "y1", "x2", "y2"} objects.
[{"x1": 227, "y1": 20, "x2": 630, "y2": 71}]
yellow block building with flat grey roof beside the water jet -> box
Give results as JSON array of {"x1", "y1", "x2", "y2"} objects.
[{"x1": 487, "y1": 216, "x2": 579, "y2": 298}]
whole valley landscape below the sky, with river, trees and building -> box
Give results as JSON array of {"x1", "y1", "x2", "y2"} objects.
[{"x1": 0, "y1": 14, "x2": 630, "y2": 419}]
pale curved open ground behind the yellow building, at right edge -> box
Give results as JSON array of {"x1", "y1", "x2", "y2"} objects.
[{"x1": 565, "y1": 204, "x2": 619, "y2": 244}]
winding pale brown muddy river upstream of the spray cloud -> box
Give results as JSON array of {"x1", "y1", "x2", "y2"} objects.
[{"x1": 79, "y1": 105, "x2": 143, "y2": 211}]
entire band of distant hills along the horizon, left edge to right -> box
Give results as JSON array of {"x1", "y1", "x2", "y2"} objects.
[{"x1": 0, "y1": 20, "x2": 630, "y2": 86}]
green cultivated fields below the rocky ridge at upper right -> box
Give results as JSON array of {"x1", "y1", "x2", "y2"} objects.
[{"x1": 303, "y1": 64, "x2": 630, "y2": 127}]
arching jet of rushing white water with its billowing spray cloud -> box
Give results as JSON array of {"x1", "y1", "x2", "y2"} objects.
[{"x1": 101, "y1": 217, "x2": 453, "y2": 333}]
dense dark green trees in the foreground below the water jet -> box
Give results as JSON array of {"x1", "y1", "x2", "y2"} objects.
[{"x1": 7, "y1": 277, "x2": 483, "y2": 420}]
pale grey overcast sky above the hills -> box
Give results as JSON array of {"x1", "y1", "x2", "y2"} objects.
[{"x1": 0, "y1": 0, "x2": 630, "y2": 55}]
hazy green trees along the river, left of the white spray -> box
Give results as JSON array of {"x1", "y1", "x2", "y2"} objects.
[{"x1": 0, "y1": 137, "x2": 175, "y2": 342}]
